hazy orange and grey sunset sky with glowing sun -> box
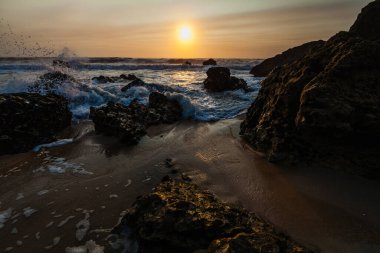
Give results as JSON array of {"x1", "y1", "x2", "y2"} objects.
[{"x1": 0, "y1": 0, "x2": 371, "y2": 58}]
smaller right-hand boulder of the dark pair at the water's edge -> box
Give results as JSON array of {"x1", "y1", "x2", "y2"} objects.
[{"x1": 149, "y1": 92, "x2": 182, "y2": 124}]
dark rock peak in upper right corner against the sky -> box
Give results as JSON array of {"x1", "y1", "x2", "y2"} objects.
[{"x1": 350, "y1": 0, "x2": 380, "y2": 40}]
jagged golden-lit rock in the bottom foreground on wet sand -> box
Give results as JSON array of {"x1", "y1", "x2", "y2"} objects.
[{"x1": 113, "y1": 179, "x2": 311, "y2": 253}]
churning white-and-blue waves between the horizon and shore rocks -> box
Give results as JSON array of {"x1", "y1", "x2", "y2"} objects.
[{"x1": 0, "y1": 59, "x2": 261, "y2": 121}]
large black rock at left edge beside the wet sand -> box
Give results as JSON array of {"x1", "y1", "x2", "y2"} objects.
[{"x1": 0, "y1": 93, "x2": 71, "y2": 155}]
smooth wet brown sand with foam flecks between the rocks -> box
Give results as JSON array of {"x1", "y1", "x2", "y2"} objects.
[{"x1": 0, "y1": 119, "x2": 380, "y2": 253}]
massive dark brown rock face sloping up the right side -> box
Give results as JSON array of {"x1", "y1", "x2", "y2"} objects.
[{"x1": 241, "y1": 0, "x2": 380, "y2": 178}]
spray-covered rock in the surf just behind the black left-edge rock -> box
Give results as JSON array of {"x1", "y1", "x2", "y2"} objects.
[{"x1": 28, "y1": 71, "x2": 76, "y2": 92}]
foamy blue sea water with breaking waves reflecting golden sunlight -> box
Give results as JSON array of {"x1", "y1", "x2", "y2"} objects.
[{"x1": 0, "y1": 58, "x2": 261, "y2": 121}]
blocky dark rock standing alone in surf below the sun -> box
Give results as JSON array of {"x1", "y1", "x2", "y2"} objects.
[{"x1": 203, "y1": 67, "x2": 249, "y2": 92}]
